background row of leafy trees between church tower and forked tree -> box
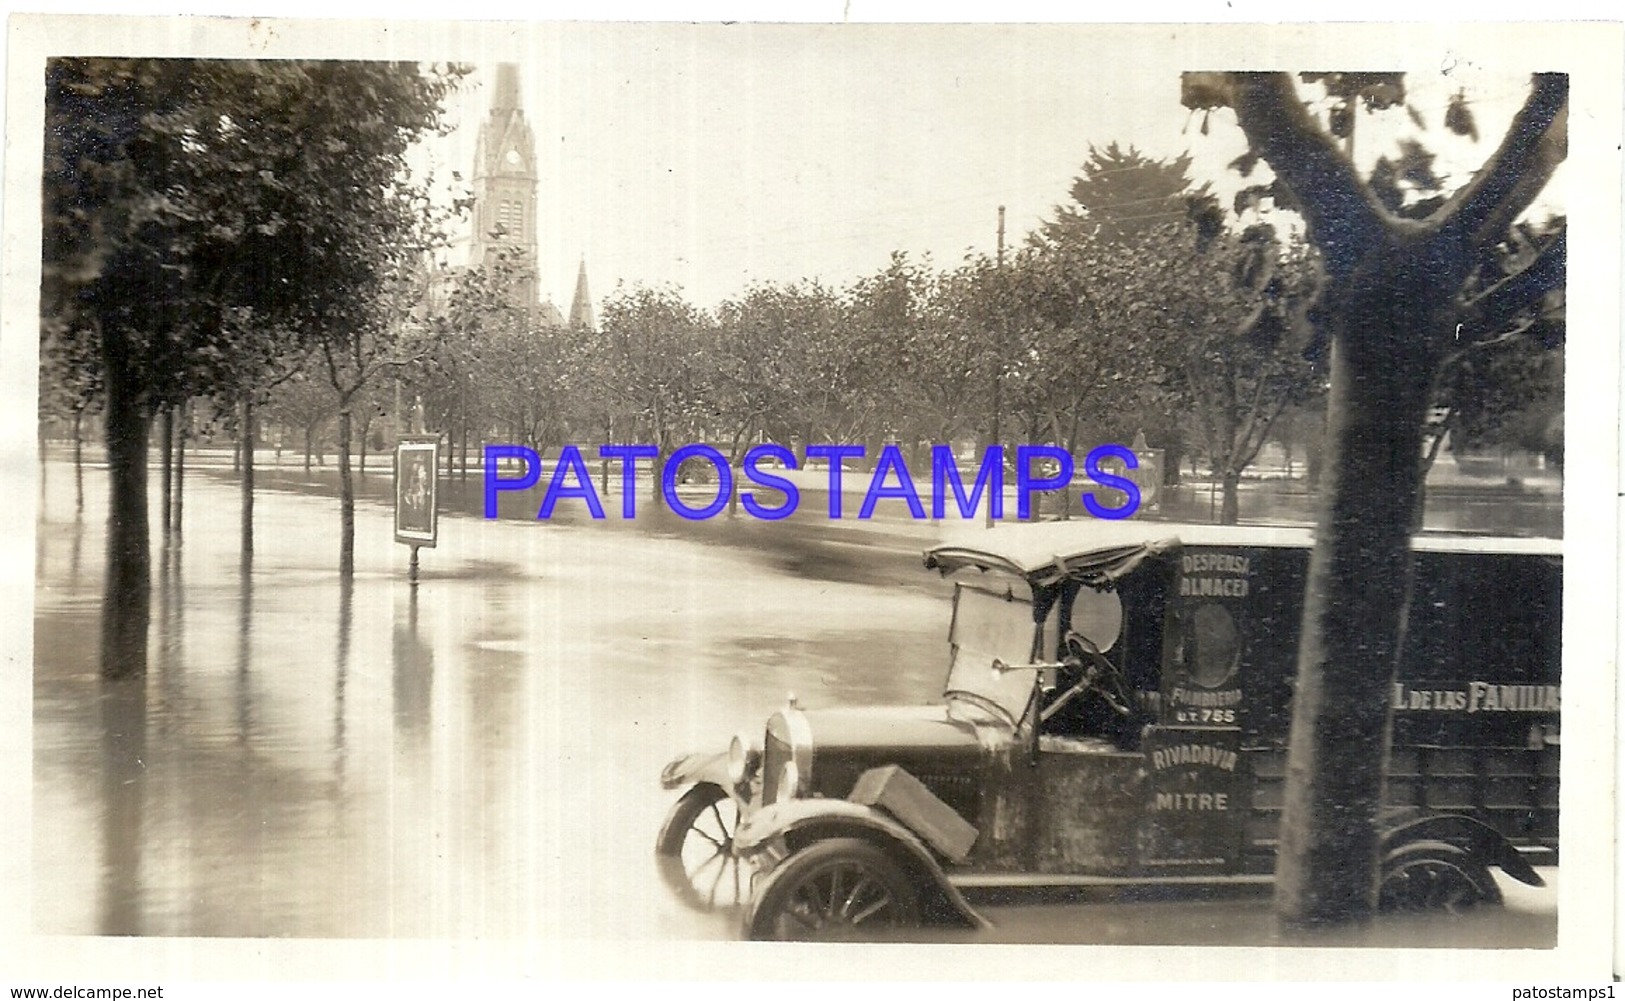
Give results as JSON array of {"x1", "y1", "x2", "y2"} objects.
[{"x1": 383, "y1": 146, "x2": 1323, "y2": 522}]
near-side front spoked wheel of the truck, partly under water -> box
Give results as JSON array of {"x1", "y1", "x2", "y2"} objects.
[{"x1": 744, "y1": 839, "x2": 920, "y2": 941}]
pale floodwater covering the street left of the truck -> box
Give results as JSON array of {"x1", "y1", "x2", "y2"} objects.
[{"x1": 34, "y1": 465, "x2": 946, "y2": 939}]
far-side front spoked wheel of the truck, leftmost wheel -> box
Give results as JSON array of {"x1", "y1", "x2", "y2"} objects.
[{"x1": 655, "y1": 782, "x2": 751, "y2": 912}]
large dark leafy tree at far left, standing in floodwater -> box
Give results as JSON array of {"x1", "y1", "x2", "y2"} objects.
[{"x1": 41, "y1": 59, "x2": 464, "y2": 676}]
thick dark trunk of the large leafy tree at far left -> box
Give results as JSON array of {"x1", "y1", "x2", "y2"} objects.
[{"x1": 101, "y1": 349, "x2": 151, "y2": 678}]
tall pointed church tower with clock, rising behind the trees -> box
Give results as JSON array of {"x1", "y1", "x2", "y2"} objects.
[{"x1": 468, "y1": 63, "x2": 542, "y2": 319}]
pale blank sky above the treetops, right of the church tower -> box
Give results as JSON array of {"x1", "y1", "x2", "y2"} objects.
[{"x1": 427, "y1": 23, "x2": 1557, "y2": 309}]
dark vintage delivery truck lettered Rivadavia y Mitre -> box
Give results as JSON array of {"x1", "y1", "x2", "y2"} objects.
[{"x1": 657, "y1": 522, "x2": 1563, "y2": 939}]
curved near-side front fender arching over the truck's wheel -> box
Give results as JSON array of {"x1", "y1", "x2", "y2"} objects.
[{"x1": 733, "y1": 800, "x2": 991, "y2": 928}]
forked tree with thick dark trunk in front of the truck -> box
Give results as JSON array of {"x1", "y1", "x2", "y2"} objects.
[{"x1": 1183, "y1": 73, "x2": 1568, "y2": 925}]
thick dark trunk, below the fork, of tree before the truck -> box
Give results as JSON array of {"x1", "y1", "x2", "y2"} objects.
[{"x1": 1276, "y1": 310, "x2": 1433, "y2": 926}]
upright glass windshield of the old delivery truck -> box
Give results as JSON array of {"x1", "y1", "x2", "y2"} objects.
[{"x1": 944, "y1": 583, "x2": 1037, "y2": 725}]
